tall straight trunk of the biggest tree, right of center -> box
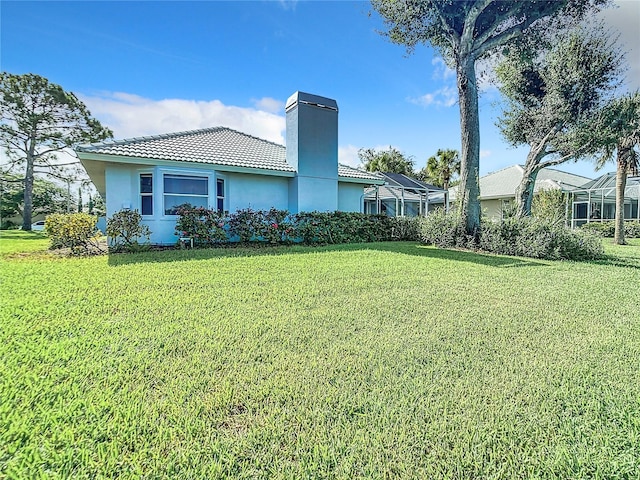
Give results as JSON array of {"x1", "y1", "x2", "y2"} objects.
[{"x1": 456, "y1": 56, "x2": 480, "y2": 237}]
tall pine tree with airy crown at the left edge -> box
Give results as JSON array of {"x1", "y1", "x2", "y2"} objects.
[{"x1": 0, "y1": 72, "x2": 113, "y2": 230}]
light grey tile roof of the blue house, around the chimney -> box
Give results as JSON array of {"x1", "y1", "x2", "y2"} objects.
[{"x1": 76, "y1": 127, "x2": 380, "y2": 181}]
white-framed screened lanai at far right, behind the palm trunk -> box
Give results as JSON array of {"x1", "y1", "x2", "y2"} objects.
[{"x1": 571, "y1": 173, "x2": 640, "y2": 228}]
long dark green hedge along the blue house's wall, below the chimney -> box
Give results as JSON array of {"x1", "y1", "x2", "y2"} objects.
[{"x1": 176, "y1": 205, "x2": 418, "y2": 246}]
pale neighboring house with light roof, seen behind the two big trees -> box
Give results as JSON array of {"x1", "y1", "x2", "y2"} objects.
[{"x1": 449, "y1": 165, "x2": 591, "y2": 220}]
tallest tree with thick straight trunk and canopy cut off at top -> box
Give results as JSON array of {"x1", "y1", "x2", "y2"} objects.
[{"x1": 371, "y1": 0, "x2": 608, "y2": 234}]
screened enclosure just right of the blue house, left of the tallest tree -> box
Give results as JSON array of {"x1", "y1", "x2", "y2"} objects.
[{"x1": 364, "y1": 172, "x2": 446, "y2": 217}]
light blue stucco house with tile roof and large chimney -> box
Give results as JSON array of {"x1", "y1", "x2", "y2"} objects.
[{"x1": 76, "y1": 92, "x2": 384, "y2": 244}]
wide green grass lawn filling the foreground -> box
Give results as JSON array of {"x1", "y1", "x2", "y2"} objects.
[{"x1": 0, "y1": 232, "x2": 640, "y2": 479}]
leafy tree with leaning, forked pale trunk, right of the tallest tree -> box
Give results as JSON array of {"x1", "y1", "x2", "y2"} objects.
[{"x1": 496, "y1": 27, "x2": 623, "y2": 217}]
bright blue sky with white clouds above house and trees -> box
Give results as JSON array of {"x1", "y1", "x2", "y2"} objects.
[{"x1": 0, "y1": 0, "x2": 640, "y2": 177}]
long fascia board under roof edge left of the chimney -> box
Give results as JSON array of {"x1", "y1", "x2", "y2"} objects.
[{"x1": 76, "y1": 151, "x2": 296, "y2": 177}]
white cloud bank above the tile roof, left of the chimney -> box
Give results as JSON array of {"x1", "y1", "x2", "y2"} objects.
[{"x1": 80, "y1": 92, "x2": 285, "y2": 144}]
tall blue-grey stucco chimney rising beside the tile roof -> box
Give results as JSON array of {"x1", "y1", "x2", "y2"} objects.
[{"x1": 285, "y1": 92, "x2": 338, "y2": 213}]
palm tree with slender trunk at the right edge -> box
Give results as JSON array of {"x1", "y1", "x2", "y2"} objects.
[{"x1": 598, "y1": 91, "x2": 640, "y2": 245}]
